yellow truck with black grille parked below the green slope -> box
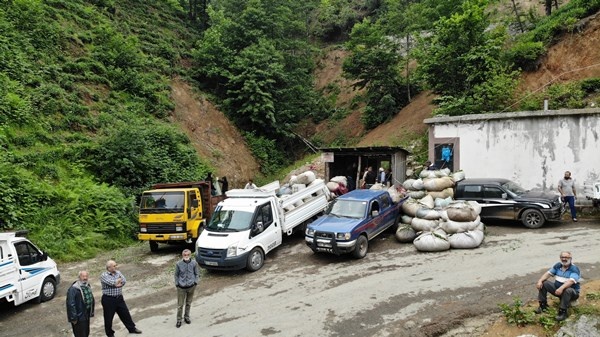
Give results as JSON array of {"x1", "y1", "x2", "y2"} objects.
[{"x1": 138, "y1": 181, "x2": 225, "y2": 252}]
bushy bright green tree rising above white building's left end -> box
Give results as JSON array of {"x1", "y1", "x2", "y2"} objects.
[{"x1": 418, "y1": 0, "x2": 515, "y2": 114}]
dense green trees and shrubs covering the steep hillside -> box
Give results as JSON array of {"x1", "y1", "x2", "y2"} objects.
[{"x1": 0, "y1": 0, "x2": 600, "y2": 260}]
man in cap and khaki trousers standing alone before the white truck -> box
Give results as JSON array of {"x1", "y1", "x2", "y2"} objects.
[{"x1": 175, "y1": 249, "x2": 200, "y2": 328}]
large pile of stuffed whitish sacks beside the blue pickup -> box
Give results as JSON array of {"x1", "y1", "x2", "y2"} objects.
[{"x1": 396, "y1": 169, "x2": 484, "y2": 252}]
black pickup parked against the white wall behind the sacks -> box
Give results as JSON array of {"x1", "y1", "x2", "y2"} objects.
[{"x1": 454, "y1": 178, "x2": 564, "y2": 228}]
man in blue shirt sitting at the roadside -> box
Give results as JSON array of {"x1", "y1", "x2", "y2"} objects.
[{"x1": 535, "y1": 252, "x2": 581, "y2": 321}]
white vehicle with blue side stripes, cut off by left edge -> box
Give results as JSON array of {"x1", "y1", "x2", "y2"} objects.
[{"x1": 0, "y1": 232, "x2": 60, "y2": 306}]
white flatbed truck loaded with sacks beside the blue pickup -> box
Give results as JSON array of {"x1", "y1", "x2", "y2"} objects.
[{"x1": 196, "y1": 179, "x2": 330, "y2": 271}]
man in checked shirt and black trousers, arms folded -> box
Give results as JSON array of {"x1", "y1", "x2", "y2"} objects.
[{"x1": 100, "y1": 260, "x2": 142, "y2": 337}]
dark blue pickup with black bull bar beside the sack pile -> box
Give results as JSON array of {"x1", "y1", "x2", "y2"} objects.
[{"x1": 305, "y1": 190, "x2": 406, "y2": 259}]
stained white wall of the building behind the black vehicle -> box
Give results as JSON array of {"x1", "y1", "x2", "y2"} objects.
[{"x1": 425, "y1": 109, "x2": 600, "y2": 196}]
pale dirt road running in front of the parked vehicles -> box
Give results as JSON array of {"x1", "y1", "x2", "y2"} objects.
[{"x1": 0, "y1": 220, "x2": 600, "y2": 337}]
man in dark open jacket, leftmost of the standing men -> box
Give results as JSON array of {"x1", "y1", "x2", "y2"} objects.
[{"x1": 67, "y1": 270, "x2": 95, "y2": 337}]
